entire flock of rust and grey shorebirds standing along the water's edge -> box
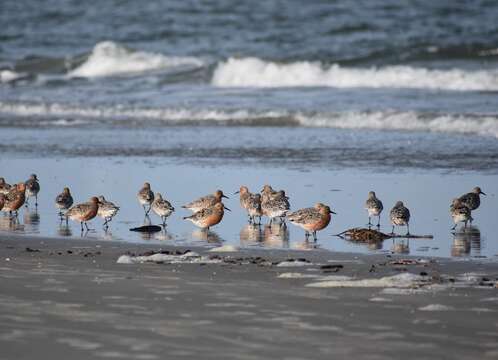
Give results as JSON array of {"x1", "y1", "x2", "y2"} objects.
[{"x1": 0, "y1": 174, "x2": 486, "y2": 240}]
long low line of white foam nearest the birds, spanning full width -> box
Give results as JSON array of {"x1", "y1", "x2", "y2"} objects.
[{"x1": 0, "y1": 101, "x2": 498, "y2": 138}]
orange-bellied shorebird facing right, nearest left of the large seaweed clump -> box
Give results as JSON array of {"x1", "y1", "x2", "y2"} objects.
[{"x1": 287, "y1": 203, "x2": 335, "y2": 241}]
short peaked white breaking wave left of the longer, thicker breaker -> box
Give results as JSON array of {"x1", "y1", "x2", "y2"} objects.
[{"x1": 68, "y1": 41, "x2": 204, "y2": 78}]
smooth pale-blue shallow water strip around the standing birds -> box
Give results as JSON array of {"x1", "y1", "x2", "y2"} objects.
[{"x1": 0, "y1": 157, "x2": 498, "y2": 259}]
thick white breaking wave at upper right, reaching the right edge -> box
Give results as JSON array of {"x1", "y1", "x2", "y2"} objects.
[{"x1": 212, "y1": 57, "x2": 498, "y2": 91}]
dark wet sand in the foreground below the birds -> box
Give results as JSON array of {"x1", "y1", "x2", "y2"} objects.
[{"x1": 0, "y1": 235, "x2": 498, "y2": 359}]
